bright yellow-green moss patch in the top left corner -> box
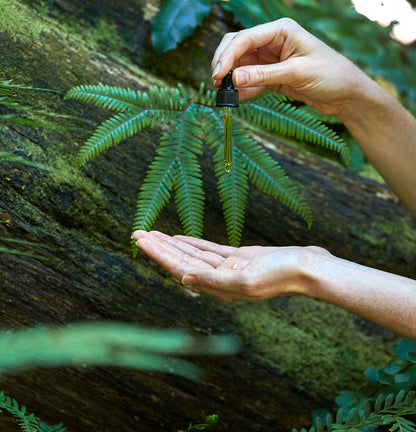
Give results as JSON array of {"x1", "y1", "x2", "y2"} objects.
[{"x1": 0, "y1": 0, "x2": 49, "y2": 42}]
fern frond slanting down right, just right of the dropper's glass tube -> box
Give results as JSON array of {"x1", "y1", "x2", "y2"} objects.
[{"x1": 233, "y1": 128, "x2": 312, "y2": 227}]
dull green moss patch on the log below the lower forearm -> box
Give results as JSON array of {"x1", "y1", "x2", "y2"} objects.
[{"x1": 234, "y1": 297, "x2": 391, "y2": 399}]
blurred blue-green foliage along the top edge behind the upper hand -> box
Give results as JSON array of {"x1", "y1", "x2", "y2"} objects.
[{"x1": 151, "y1": 0, "x2": 416, "y2": 102}]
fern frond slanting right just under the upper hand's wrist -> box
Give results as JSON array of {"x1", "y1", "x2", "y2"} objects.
[{"x1": 237, "y1": 93, "x2": 348, "y2": 159}]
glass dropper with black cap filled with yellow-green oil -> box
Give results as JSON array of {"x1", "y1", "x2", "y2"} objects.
[{"x1": 216, "y1": 71, "x2": 238, "y2": 172}]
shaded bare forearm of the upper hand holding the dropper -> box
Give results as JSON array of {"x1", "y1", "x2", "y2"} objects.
[{"x1": 338, "y1": 77, "x2": 416, "y2": 216}]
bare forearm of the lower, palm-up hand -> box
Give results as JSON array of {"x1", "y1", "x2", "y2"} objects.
[{"x1": 306, "y1": 254, "x2": 416, "y2": 339}]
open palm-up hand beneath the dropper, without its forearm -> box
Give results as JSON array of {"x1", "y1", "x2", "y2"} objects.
[{"x1": 133, "y1": 231, "x2": 328, "y2": 302}]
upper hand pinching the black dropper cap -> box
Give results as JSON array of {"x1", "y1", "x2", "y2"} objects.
[{"x1": 212, "y1": 18, "x2": 369, "y2": 115}]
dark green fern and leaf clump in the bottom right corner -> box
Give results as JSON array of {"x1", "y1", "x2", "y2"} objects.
[{"x1": 294, "y1": 339, "x2": 416, "y2": 432}]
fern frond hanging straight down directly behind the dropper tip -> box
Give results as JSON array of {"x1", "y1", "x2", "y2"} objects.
[{"x1": 215, "y1": 146, "x2": 248, "y2": 247}]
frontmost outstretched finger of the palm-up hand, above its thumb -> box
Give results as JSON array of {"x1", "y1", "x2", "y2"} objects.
[{"x1": 136, "y1": 236, "x2": 211, "y2": 280}]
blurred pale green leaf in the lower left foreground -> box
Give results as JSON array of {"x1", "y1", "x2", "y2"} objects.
[{"x1": 0, "y1": 322, "x2": 237, "y2": 380}]
